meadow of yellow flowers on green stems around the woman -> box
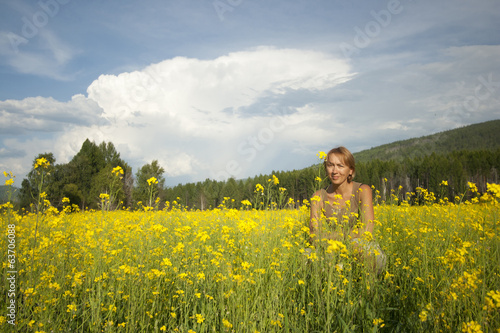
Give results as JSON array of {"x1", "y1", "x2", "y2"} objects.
[{"x1": 0, "y1": 169, "x2": 500, "y2": 333}]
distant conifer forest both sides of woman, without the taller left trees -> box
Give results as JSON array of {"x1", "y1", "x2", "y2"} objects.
[{"x1": 165, "y1": 149, "x2": 500, "y2": 209}]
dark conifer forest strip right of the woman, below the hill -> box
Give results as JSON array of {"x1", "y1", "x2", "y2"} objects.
[{"x1": 356, "y1": 148, "x2": 500, "y2": 201}]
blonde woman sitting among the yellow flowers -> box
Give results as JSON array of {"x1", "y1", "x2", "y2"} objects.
[{"x1": 309, "y1": 147, "x2": 386, "y2": 271}]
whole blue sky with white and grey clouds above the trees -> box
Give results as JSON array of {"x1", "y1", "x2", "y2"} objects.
[{"x1": 0, "y1": 0, "x2": 500, "y2": 186}]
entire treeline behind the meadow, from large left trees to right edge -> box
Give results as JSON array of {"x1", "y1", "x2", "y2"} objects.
[{"x1": 7, "y1": 140, "x2": 500, "y2": 210}]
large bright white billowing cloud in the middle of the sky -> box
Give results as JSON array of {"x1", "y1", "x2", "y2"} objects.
[{"x1": 87, "y1": 47, "x2": 353, "y2": 178}]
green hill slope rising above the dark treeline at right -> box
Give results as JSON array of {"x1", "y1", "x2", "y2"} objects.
[{"x1": 353, "y1": 120, "x2": 500, "y2": 162}]
